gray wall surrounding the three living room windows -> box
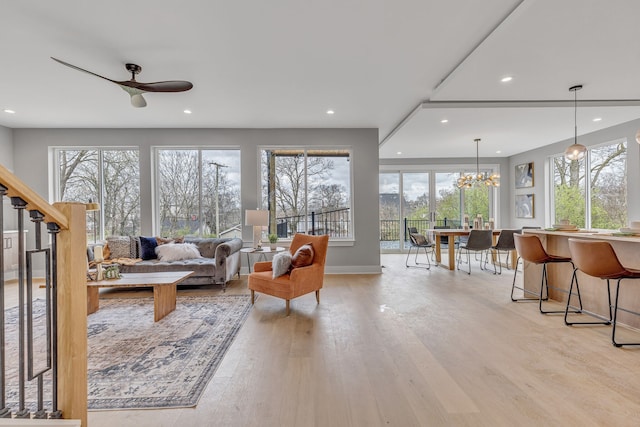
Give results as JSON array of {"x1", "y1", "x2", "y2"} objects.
[{"x1": 11, "y1": 129, "x2": 381, "y2": 273}]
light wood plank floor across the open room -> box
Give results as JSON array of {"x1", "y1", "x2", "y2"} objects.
[{"x1": 16, "y1": 255, "x2": 640, "y2": 427}]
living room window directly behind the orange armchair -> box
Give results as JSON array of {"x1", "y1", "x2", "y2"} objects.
[{"x1": 261, "y1": 147, "x2": 353, "y2": 238}]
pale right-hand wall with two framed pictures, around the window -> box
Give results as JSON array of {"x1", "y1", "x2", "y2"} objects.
[{"x1": 502, "y1": 119, "x2": 640, "y2": 228}]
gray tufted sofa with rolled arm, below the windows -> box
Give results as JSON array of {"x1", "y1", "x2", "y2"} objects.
[{"x1": 104, "y1": 237, "x2": 242, "y2": 288}]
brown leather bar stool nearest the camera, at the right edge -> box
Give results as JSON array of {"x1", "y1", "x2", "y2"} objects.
[{"x1": 564, "y1": 239, "x2": 640, "y2": 347}]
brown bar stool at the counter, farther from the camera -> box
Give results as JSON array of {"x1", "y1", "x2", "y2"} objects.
[{"x1": 511, "y1": 234, "x2": 582, "y2": 314}]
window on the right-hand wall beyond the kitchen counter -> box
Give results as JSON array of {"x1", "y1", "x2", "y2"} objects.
[{"x1": 551, "y1": 140, "x2": 627, "y2": 229}]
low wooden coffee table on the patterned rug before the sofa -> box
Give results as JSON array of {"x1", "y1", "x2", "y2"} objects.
[{"x1": 87, "y1": 271, "x2": 193, "y2": 322}]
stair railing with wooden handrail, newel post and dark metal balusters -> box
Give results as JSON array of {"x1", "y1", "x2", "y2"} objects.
[{"x1": 0, "y1": 165, "x2": 87, "y2": 426}]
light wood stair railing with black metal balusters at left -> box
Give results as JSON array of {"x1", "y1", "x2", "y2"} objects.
[{"x1": 0, "y1": 164, "x2": 88, "y2": 426}]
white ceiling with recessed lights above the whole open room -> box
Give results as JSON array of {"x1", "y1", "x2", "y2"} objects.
[{"x1": 0, "y1": 0, "x2": 640, "y2": 158}]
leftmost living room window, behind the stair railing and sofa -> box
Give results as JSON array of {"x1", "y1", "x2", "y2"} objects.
[{"x1": 54, "y1": 148, "x2": 140, "y2": 241}]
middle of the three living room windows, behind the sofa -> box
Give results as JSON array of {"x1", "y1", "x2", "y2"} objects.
[{"x1": 155, "y1": 148, "x2": 242, "y2": 237}]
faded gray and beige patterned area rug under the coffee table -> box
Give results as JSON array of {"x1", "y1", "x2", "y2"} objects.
[{"x1": 7, "y1": 295, "x2": 251, "y2": 410}]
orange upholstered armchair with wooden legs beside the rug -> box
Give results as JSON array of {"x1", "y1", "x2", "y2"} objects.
[{"x1": 249, "y1": 234, "x2": 329, "y2": 316}]
